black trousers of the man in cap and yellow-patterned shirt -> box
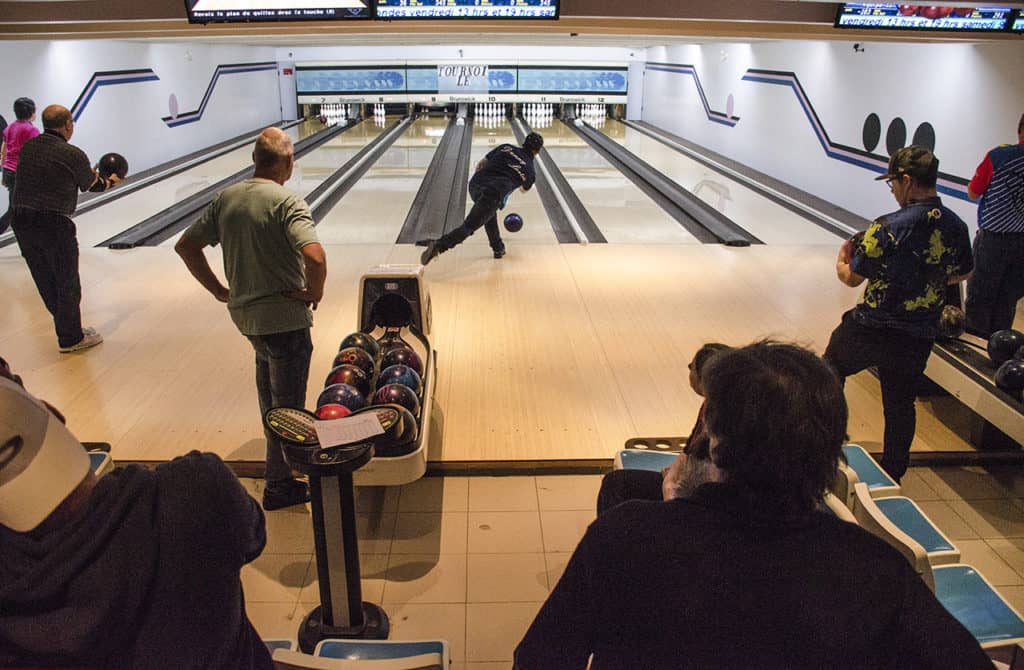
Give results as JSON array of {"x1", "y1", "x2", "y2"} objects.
[{"x1": 824, "y1": 309, "x2": 933, "y2": 481}]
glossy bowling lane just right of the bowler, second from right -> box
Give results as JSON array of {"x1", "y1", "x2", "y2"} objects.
[{"x1": 541, "y1": 117, "x2": 699, "y2": 244}]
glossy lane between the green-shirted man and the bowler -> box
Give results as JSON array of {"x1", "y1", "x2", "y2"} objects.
[{"x1": 316, "y1": 117, "x2": 449, "y2": 246}]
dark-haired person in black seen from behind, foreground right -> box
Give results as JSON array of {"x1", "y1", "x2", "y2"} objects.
[{"x1": 514, "y1": 342, "x2": 992, "y2": 670}]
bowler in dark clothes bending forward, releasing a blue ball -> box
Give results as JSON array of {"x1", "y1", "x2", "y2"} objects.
[{"x1": 420, "y1": 132, "x2": 544, "y2": 265}]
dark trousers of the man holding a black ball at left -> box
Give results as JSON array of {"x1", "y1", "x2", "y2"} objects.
[{"x1": 11, "y1": 208, "x2": 84, "y2": 346}]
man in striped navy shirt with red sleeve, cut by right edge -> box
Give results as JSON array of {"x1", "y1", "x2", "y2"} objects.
[{"x1": 967, "y1": 115, "x2": 1024, "y2": 337}]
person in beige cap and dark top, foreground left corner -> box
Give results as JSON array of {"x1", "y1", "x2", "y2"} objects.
[{"x1": 0, "y1": 360, "x2": 273, "y2": 670}]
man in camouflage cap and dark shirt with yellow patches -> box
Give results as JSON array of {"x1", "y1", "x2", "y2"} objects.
[{"x1": 824, "y1": 145, "x2": 974, "y2": 481}]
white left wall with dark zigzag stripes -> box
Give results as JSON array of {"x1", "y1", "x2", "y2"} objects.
[{"x1": 0, "y1": 40, "x2": 282, "y2": 176}]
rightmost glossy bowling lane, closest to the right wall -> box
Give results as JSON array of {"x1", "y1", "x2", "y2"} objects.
[{"x1": 596, "y1": 119, "x2": 842, "y2": 247}]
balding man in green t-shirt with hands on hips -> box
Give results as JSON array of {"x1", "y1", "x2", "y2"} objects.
[{"x1": 174, "y1": 128, "x2": 327, "y2": 511}]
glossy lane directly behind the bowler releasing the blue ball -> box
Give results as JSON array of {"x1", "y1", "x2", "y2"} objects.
[{"x1": 466, "y1": 117, "x2": 557, "y2": 247}]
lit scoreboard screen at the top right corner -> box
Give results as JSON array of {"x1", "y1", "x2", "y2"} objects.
[{"x1": 836, "y1": 2, "x2": 1013, "y2": 32}]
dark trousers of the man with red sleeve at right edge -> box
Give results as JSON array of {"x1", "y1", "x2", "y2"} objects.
[{"x1": 967, "y1": 231, "x2": 1024, "y2": 337}]
